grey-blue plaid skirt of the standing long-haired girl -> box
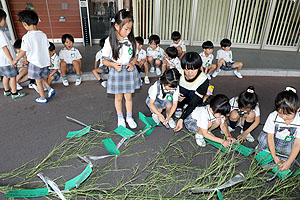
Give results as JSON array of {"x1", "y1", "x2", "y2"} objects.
[{"x1": 107, "y1": 65, "x2": 142, "y2": 94}]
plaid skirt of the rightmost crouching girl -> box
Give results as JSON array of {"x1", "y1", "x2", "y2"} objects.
[{"x1": 258, "y1": 131, "x2": 295, "y2": 160}]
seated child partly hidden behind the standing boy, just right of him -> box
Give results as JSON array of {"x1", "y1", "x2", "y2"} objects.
[{"x1": 48, "y1": 42, "x2": 60, "y2": 85}]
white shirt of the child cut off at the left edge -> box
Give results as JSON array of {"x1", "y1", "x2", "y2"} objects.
[{"x1": 0, "y1": 30, "x2": 16, "y2": 67}]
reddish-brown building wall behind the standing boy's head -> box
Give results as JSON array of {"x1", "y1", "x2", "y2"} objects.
[{"x1": 8, "y1": 0, "x2": 82, "y2": 39}]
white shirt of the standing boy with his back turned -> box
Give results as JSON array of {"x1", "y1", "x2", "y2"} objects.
[{"x1": 21, "y1": 31, "x2": 50, "y2": 68}]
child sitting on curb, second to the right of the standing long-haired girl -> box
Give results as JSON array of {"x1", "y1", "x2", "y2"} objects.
[{"x1": 147, "y1": 35, "x2": 165, "y2": 76}]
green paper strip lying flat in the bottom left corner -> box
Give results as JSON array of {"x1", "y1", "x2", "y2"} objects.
[{"x1": 5, "y1": 188, "x2": 49, "y2": 198}]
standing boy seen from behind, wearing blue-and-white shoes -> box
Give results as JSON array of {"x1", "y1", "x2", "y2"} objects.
[{"x1": 13, "y1": 10, "x2": 55, "y2": 103}]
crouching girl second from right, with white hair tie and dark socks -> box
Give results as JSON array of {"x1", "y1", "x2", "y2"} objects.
[{"x1": 228, "y1": 86, "x2": 260, "y2": 142}]
